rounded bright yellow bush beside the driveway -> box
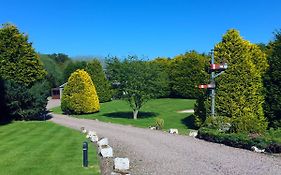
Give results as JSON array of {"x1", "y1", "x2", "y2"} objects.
[{"x1": 61, "y1": 69, "x2": 100, "y2": 114}]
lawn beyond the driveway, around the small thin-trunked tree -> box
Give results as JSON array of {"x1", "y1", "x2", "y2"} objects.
[{"x1": 52, "y1": 98, "x2": 195, "y2": 134}]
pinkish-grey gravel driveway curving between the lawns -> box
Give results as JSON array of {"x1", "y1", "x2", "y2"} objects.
[{"x1": 47, "y1": 99, "x2": 281, "y2": 175}]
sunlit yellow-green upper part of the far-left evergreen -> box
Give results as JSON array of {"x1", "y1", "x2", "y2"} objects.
[{"x1": 0, "y1": 24, "x2": 46, "y2": 85}]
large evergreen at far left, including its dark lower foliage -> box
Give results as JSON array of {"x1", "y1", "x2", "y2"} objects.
[{"x1": 0, "y1": 24, "x2": 48, "y2": 120}]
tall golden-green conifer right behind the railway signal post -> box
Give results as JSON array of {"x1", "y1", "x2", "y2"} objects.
[{"x1": 215, "y1": 29, "x2": 268, "y2": 132}]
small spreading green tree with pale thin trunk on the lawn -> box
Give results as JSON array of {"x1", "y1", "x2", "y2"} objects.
[{"x1": 107, "y1": 56, "x2": 166, "y2": 119}]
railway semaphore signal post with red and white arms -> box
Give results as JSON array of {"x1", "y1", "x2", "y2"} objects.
[{"x1": 198, "y1": 50, "x2": 227, "y2": 117}]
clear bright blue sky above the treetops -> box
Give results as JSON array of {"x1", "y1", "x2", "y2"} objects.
[{"x1": 0, "y1": 0, "x2": 281, "y2": 59}]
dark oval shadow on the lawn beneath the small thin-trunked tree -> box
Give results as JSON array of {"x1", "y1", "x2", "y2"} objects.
[{"x1": 104, "y1": 112, "x2": 158, "y2": 119}]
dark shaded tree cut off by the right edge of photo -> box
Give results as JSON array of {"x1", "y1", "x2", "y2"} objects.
[{"x1": 264, "y1": 32, "x2": 281, "y2": 128}]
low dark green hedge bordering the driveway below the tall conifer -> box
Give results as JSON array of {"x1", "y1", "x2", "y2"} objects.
[{"x1": 197, "y1": 128, "x2": 281, "y2": 153}]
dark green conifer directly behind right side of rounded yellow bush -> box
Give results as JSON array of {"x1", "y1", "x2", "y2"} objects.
[{"x1": 86, "y1": 59, "x2": 112, "y2": 103}]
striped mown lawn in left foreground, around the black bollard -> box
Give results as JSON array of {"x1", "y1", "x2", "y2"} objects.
[{"x1": 0, "y1": 122, "x2": 100, "y2": 175}]
